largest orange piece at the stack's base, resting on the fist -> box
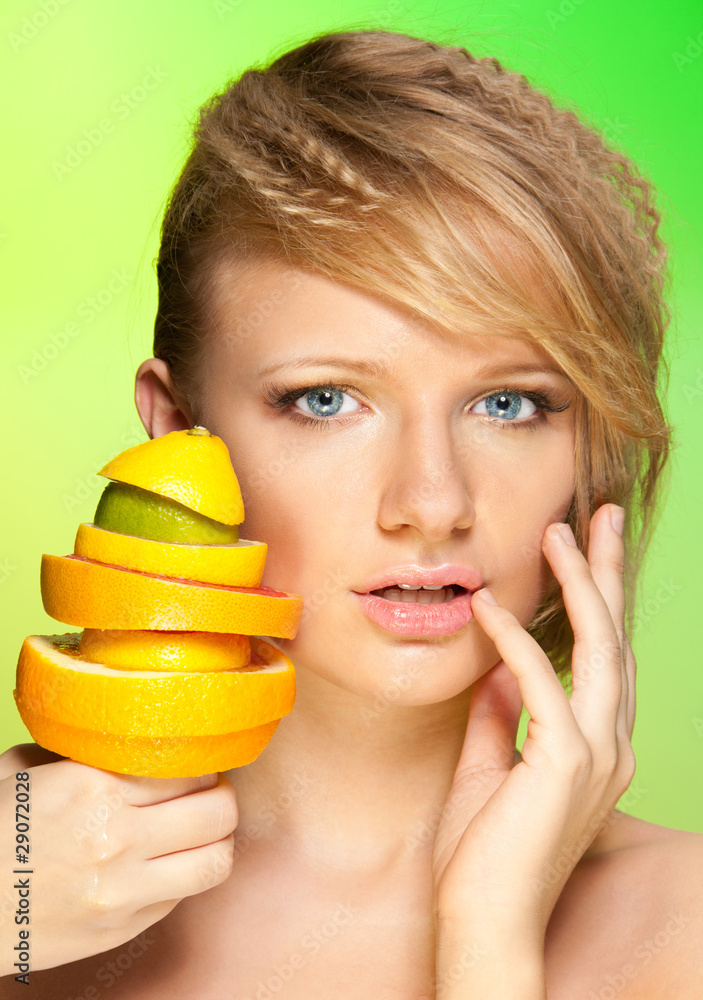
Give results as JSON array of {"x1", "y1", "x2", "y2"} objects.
[{"x1": 14, "y1": 633, "x2": 295, "y2": 778}]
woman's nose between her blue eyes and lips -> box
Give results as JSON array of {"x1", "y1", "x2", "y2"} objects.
[{"x1": 378, "y1": 413, "x2": 476, "y2": 542}]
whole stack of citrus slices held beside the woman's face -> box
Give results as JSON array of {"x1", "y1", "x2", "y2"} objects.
[{"x1": 14, "y1": 427, "x2": 303, "y2": 778}]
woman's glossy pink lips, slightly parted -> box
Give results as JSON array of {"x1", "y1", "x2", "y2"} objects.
[{"x1": 353, "y1": 564, "x2": 483, "y2": 637}]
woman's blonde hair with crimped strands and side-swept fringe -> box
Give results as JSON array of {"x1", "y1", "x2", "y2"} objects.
[{"x1": 154, "y1": 30, "x2": 671, "y2": 678}]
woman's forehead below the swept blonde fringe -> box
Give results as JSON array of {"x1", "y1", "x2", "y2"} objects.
[{"x1": 210, "y1": 252, "x2": 557, "y2": 368}]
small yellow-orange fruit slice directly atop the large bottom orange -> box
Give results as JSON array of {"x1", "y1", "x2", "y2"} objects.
[{"x1": 79, "y1": 628, "x2": 251, "y2": 672}]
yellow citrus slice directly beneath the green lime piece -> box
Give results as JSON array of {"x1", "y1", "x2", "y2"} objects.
[{"x1": 73, "y1": 523, "x2": 268, "y2": 587}]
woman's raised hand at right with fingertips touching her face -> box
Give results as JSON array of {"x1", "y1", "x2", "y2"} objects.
[{"x1": 432, "y1": 504, "x2": 636, "y2": 1000}]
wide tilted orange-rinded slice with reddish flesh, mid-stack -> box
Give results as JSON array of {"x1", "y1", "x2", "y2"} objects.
[{"x1": 41, "y1": 555, "x2": 303, "y2": 639}]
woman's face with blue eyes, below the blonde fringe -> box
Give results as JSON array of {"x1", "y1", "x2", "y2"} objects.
[{"x1": 198, "y1": 262, "x2": 576, "y2": 705}]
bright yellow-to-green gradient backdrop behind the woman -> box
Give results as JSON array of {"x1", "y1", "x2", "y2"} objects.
[{"x1": 0, "y1": 0, "x2": 703, "y2": 832}]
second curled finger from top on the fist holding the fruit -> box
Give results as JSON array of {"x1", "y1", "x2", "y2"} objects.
[{"x1": 139, "y1": 774, "x2": 239, "y2": 859}]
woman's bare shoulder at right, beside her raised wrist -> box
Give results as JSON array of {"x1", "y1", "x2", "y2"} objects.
[{"x1": 547, "y1": 810, "x2": 703, "y2": 1000}]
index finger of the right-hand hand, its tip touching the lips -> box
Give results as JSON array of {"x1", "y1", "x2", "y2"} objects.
[{"x1": 471, "y1": 588, "x2": 575, "y2": 736}]
